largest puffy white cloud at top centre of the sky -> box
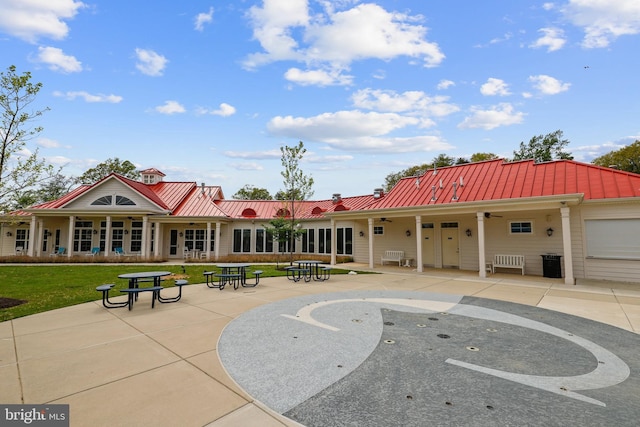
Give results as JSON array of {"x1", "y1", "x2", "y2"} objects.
[{"x1": 244, "y1": 0, "x2": 444, "y2": 86}]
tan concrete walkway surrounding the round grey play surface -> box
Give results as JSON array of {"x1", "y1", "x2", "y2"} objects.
[{"x1": 0, "y1": 264, "x2": 640, "y2": 427}]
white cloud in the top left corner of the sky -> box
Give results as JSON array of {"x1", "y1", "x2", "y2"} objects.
[{"x1": 0, "y1": 0, "x2": 85, "y2": 43}]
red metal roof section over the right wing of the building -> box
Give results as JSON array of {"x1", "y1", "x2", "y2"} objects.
[{"x1": 370, "y1": 159, "x2": 640, "y2": 209}]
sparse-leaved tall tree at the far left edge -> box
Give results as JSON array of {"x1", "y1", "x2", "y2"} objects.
[{"x1": 0, "y1": 65, "x2": 55, "y2": 211}]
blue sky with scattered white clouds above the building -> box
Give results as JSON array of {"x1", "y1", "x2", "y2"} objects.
[{"x1": 0, "y1": 0, "x2": 640, "y2": 199}]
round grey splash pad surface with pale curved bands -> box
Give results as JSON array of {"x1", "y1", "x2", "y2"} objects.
[{"x1": 218, "y1": 291, "x2": 640, "y2": 427}]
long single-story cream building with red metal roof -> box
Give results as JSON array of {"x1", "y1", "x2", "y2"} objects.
[{"x1": 0, "y1": 159, "x2": 640, "y2": 284}]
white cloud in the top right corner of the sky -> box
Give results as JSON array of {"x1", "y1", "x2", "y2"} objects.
[{"x1": 562, "y1": 0, "x2": 640, "y2": 48}]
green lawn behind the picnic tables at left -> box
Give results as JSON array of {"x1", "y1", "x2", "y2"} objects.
[{"x1": 0, "y1": 264, "x2": 360, "y2": 322}]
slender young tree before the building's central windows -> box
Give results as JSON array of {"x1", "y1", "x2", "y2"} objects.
[{"x1": 268, "y1": 141, "x2": 313, "y2": 263}]
